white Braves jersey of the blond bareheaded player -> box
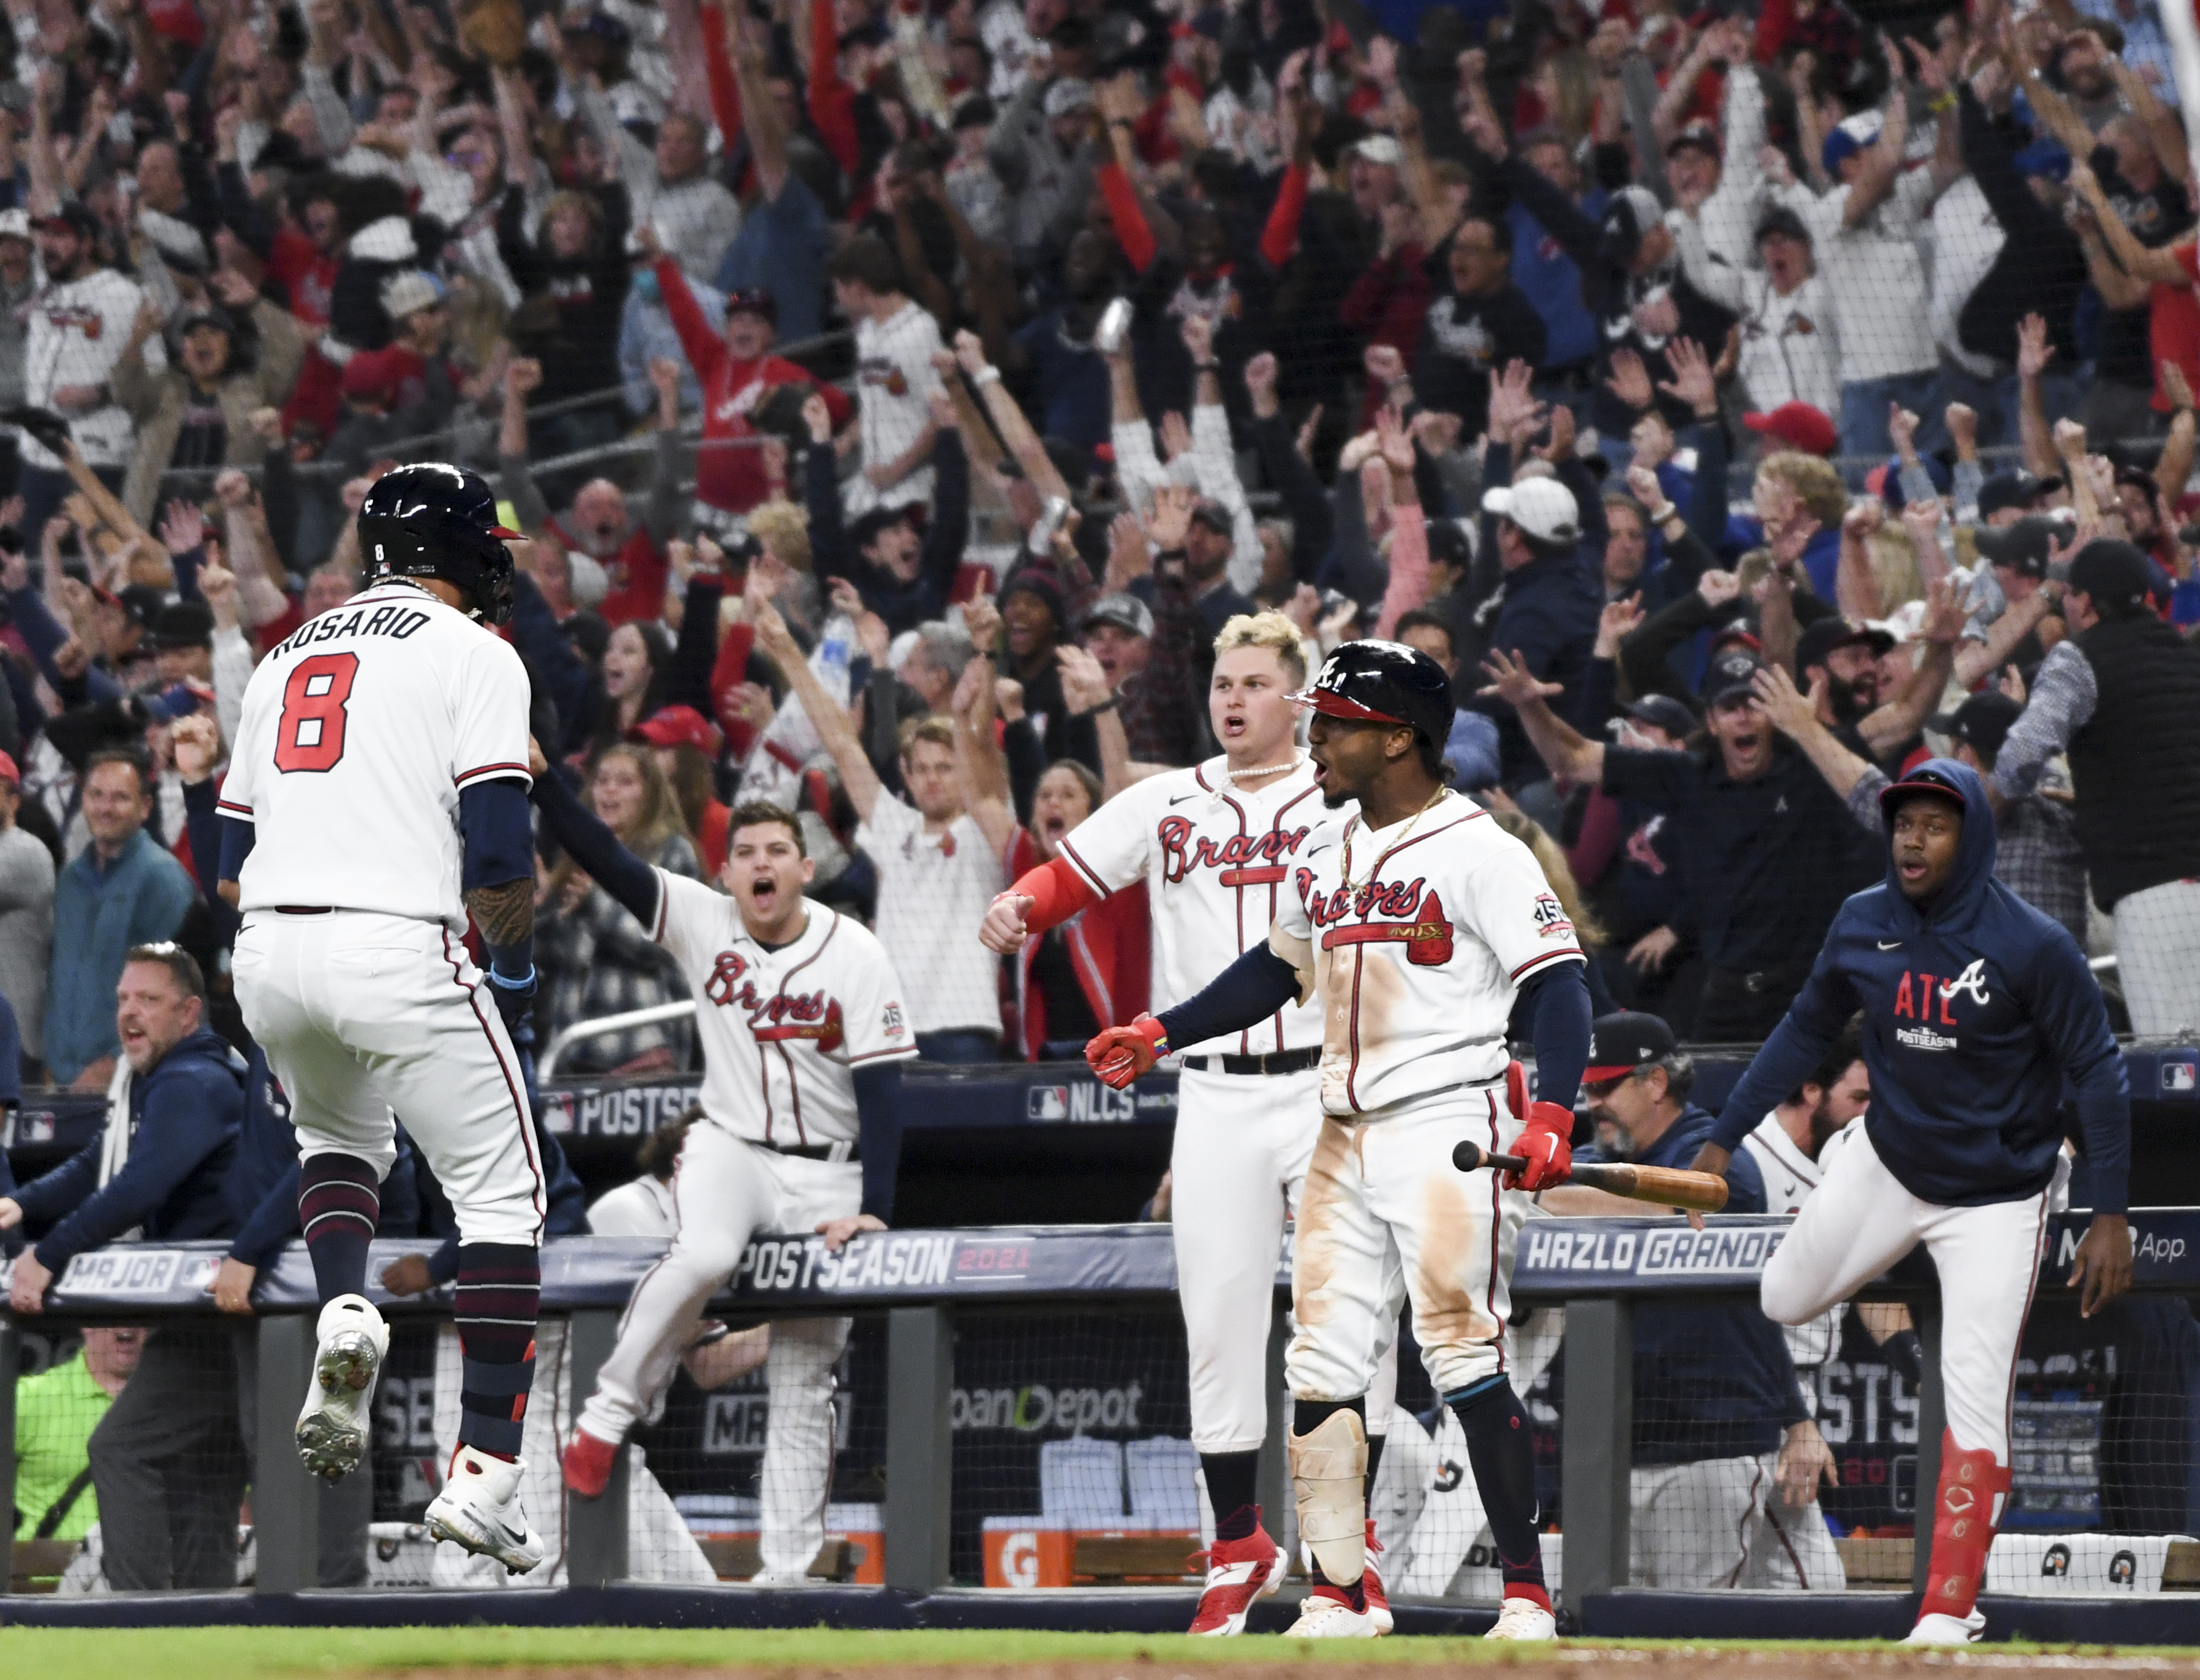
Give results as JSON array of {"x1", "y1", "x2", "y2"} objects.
[{"x1": 1063, "y1": 756, "x2": 1329, "y2": 1056}]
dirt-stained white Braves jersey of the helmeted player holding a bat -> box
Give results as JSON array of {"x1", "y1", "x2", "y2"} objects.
[{"x1": 1274, "y1": 789, "x2": 1584, "y2": 1117}]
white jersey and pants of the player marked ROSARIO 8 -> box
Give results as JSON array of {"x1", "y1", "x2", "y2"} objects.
[{"x1": 220, "y1": 578, "x2": 544, "y2": 1244}]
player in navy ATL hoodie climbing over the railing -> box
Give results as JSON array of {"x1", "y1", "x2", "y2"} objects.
[{"x1": 1696, "y1": 759, "x2": 2132, "y2": 1645}]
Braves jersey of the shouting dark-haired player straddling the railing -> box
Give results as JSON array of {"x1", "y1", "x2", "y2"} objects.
[{"x1": 651, "y1": 868, "x2": 918, "y2": 1148}]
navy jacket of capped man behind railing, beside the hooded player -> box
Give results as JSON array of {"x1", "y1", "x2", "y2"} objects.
[{"x1": 1575, "y1": 1104, "x2": 1809, "y2": 1465}]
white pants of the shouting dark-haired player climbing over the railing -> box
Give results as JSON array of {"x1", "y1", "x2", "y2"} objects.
[{"x1": 581, "y1": 1119, "x2": 862, "y2": 1581}]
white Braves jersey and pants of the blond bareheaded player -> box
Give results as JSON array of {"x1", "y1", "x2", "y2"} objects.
[{"x1": 1063, "y1": 756, "x2": 1395, "y2": 1453}]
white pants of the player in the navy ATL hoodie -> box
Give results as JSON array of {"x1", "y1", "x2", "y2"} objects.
[{"x1": 1760, "y1": 1132, "x2": 2048, "y2": 1465}]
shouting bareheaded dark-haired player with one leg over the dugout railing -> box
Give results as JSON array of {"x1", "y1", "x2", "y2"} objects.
[{"x1": 535, "y1": 759, "x2": 918, "y2": 1585}]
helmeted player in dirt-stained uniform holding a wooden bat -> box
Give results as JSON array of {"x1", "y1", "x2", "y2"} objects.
[{"x1": 1085, "y1": 642, "x2": 1588, "y2": 1638}]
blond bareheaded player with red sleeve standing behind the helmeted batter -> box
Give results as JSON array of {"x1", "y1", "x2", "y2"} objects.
[{"x1": 979, "y1": 614, "x2": 1397, "y2": 1636}]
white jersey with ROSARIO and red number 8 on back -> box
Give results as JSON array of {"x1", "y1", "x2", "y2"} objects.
[{"x1": 220, "y1": 578, "x2": 530, "y2": 928}]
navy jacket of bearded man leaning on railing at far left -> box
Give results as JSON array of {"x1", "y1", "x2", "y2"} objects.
[{"x1": 15, "y1": 1027, "x2": 244, "y2": 1275}]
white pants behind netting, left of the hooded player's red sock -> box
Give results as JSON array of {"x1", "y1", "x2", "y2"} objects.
[{"x1": 1628, "y1": 1453, "x2": 1848, "y2": 1592}]
